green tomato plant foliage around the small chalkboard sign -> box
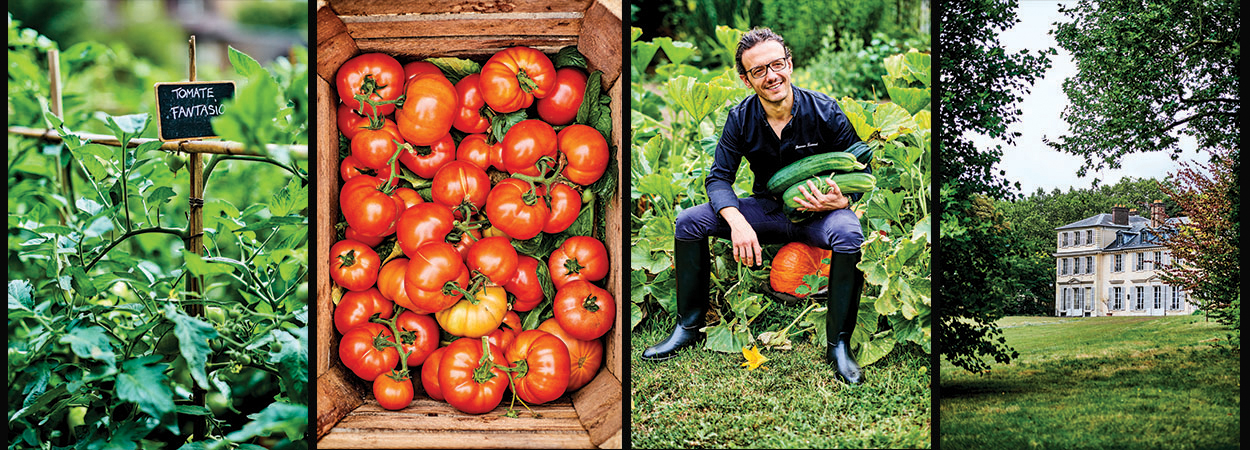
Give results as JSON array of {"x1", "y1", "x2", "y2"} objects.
[{"x1": 8, "y1": 18, "x2": 309, "y2": 449}]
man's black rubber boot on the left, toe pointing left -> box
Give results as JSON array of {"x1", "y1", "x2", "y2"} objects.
[{"x1": 643, "y1": 239, "x2": 711, "y2": 361}]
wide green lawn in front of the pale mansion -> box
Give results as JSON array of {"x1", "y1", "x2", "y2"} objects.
[{"x1": 940, "y1": 316, "x2": 1241, "y2": 449}]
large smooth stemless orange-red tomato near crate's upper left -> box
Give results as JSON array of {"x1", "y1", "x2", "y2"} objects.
[{"x1": 395, "y1": 74, "x2": 460, "y2": 145}]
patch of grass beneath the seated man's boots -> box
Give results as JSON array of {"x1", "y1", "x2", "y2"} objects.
[{"x1": 630, "y1": 305, "x2": 933, "y2": 449}]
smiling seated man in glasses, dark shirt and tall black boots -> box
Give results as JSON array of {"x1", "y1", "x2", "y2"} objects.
[{"x1": 643, "y1": 29, "x2": 864, "y2": 384}]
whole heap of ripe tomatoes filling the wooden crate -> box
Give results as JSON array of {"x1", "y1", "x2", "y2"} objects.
[{"x1": 330, "y1": 46, "x2": 616, "y2": 414}]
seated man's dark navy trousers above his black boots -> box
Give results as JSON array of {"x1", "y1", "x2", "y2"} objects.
[{"x1": 675, "y1": 198, "x2": 864, "y2": 254}]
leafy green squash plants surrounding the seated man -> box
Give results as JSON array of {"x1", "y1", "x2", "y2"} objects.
[{"x1": 630, "y1": 26, "x2": 933, "y2": 365}]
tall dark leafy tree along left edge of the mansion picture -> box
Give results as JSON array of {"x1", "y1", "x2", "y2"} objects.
[{"x1": 935, "y1": 0, "x2": 1054, "y2": 371}]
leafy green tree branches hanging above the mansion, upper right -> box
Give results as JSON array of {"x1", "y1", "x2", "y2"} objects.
[{"x1": 1046, "y1": 0, "x2": 1241, "y2": 175}]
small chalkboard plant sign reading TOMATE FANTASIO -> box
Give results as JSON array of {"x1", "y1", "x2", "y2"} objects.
[{"x1": 156, "y1": 81, "x2": 235, "y2": 141}]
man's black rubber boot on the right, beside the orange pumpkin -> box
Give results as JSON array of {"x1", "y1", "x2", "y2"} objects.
[{"x1": 825, "y1": 251, "x2": 864, "y2": 385}]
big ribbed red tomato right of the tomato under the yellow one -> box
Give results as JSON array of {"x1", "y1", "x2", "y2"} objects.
[{"x1": 504, "y1": 330, "x2": 569, "y2": 404}]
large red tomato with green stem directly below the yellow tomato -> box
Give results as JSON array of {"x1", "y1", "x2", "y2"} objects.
[{"x1": 439, "y1": 339, "x2": 509, "y2": 414}]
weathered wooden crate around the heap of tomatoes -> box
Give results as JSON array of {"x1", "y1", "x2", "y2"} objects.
[{"x1": 314, "y1": 0, "x2": 628, "y2": 449}]
